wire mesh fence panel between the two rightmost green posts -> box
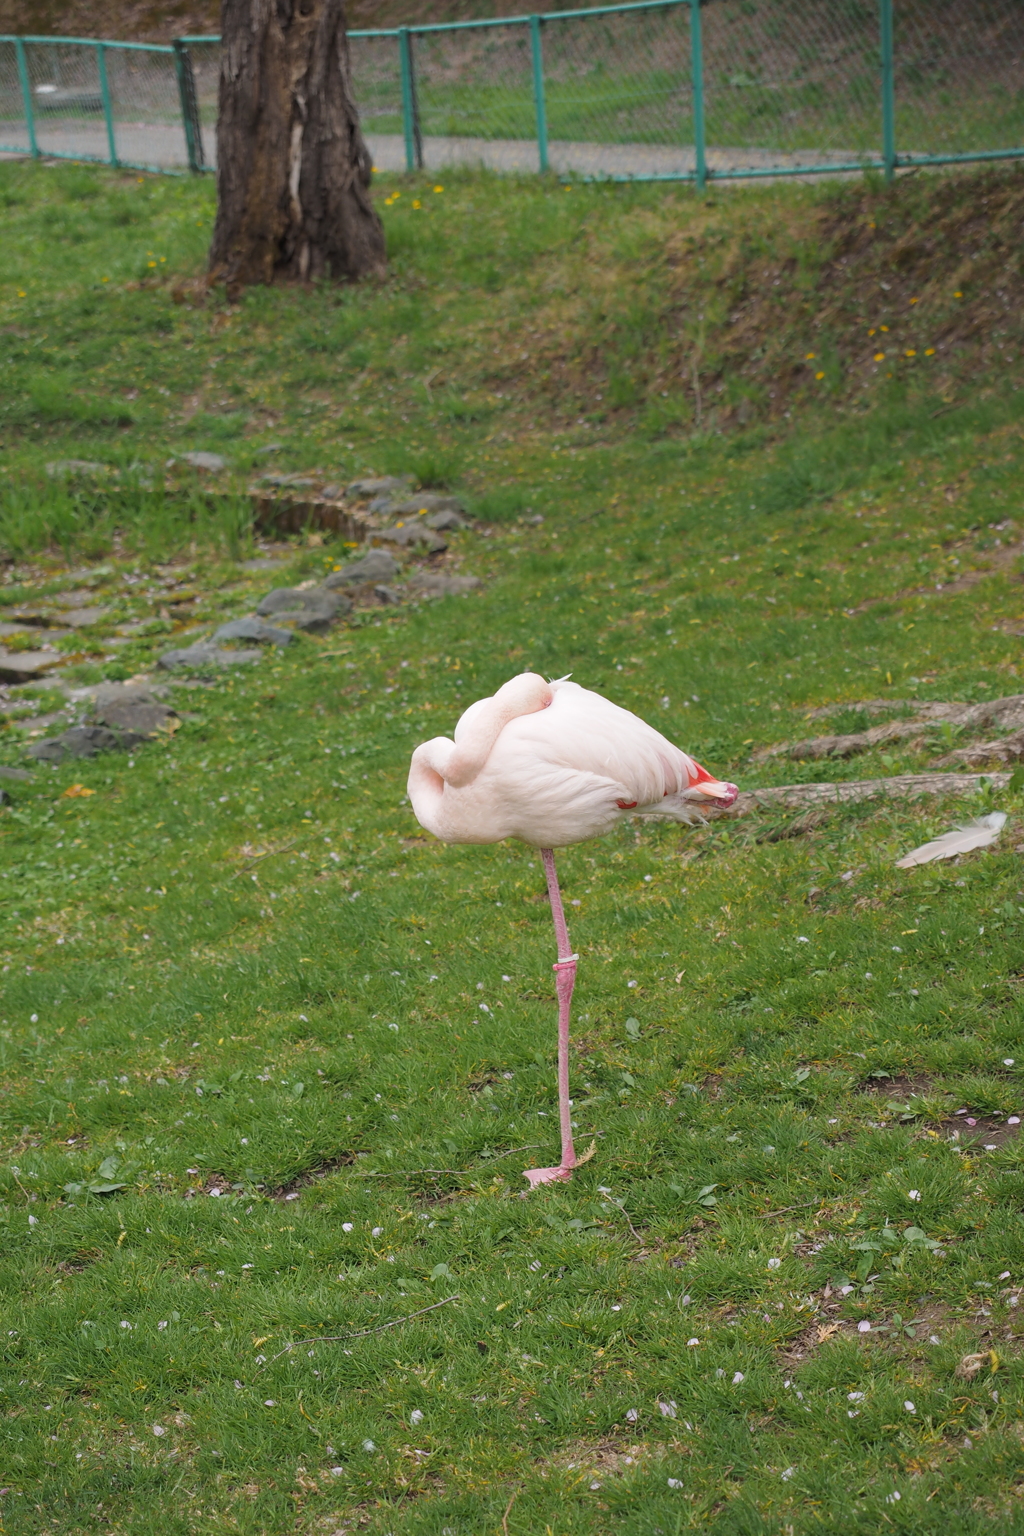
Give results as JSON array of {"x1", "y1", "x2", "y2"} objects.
[{"x1": 702, "y1": 0, "x2": 884, "y2": 175}]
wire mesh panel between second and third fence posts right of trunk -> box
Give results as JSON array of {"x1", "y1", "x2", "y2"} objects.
[{"x1": 542, "y1": 5, "x2": 694, "y2": 175}]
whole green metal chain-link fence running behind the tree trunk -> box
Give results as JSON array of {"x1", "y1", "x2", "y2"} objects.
[{"x1": 0, "y1": 0, "x2": 1024, "y2": 187}]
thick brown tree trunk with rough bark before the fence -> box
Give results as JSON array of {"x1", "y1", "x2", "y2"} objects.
[{"x1": 210, "y1": 0, "x2": 385, "y2": 292}]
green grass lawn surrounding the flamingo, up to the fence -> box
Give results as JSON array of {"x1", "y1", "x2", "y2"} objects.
[{"x1": 0, "y1": 152, "x2": 1024, "y2": 1536}]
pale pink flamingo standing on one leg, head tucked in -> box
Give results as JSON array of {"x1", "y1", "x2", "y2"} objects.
[{"x1": 408, "y1": 673, "x2": 738, "y2": 1189}]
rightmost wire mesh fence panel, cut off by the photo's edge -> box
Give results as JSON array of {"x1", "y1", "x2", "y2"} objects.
[{"x1": 894, "y1": 0, "x2": 1024, "y2": 160}]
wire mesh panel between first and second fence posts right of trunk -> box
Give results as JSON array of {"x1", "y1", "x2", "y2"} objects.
[{"x1": 405, "y1": 22, "x2": 537, "y2": 170}]
